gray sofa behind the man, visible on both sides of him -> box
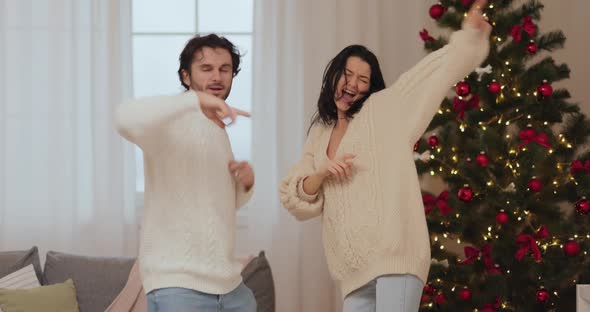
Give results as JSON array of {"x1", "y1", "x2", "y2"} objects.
[{"x1": 0, "y1": 247, "x2": 275, "y2": 312}]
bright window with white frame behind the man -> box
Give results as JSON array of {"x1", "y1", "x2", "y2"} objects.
[{"x1": 132, "y1": 0, "x2": 254, "y2": 193}]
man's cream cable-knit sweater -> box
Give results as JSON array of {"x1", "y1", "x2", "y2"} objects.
[{"x1": 117, "y1": 91, "x2": 252, "y2": 294}]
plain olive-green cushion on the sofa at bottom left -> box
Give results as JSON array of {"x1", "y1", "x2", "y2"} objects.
[{"x1": 0, "y1": 279, "x2": 79, "y2": 312}]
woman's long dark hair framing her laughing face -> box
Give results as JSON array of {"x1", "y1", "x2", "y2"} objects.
[{"x1": 308, "y1": 44, "x2": 385, "y2": 132}]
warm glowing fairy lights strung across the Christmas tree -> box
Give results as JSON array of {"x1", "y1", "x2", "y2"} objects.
[{"x1": 423, "y1": 4, "x2": 590, "y2": 311}]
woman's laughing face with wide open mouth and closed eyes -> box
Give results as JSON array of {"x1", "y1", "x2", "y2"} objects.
[{"x1": 334, "y1": 56, "x2": 371, "y2": 112}]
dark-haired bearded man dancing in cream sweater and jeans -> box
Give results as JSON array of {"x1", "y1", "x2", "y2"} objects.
[{"x1": 117, "y1": 34, "x2": 256, "y2": 312}]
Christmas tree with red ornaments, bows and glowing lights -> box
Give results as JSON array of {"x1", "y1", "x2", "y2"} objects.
[{"x1": 414, "y1": 0, "x2": 590, "y2": 311}]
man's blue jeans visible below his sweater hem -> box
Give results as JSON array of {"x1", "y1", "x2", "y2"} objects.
[{"x1": 147, "y1": 283, "x2": 256, "y2": 312}]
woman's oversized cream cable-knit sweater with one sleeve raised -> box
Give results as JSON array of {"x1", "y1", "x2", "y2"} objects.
[{"x1": 280, "y1": 26, "x2": 489, "y2": 296}]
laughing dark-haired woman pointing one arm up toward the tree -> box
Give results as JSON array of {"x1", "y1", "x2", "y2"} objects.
[{"x1": 280, "y1": 0, "x2": 491, "y2": 312}]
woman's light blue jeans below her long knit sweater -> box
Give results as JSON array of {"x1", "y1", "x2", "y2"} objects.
[{"x1": 342, "y1": 274, "x2": 424, "y2": 312}]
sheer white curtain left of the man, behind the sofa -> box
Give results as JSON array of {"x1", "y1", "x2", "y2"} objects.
[{"x1": 0, "y1": 0, "x2": 137, "y2": 256}]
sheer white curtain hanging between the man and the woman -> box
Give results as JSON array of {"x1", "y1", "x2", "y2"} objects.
[{"x1": 250, "y1": 0, "x2": 333, "y2": 312}]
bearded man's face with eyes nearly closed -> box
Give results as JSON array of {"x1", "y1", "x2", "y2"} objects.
[{"x1": 182, "y1": 47, "x2": 233, "y2": 100}]
